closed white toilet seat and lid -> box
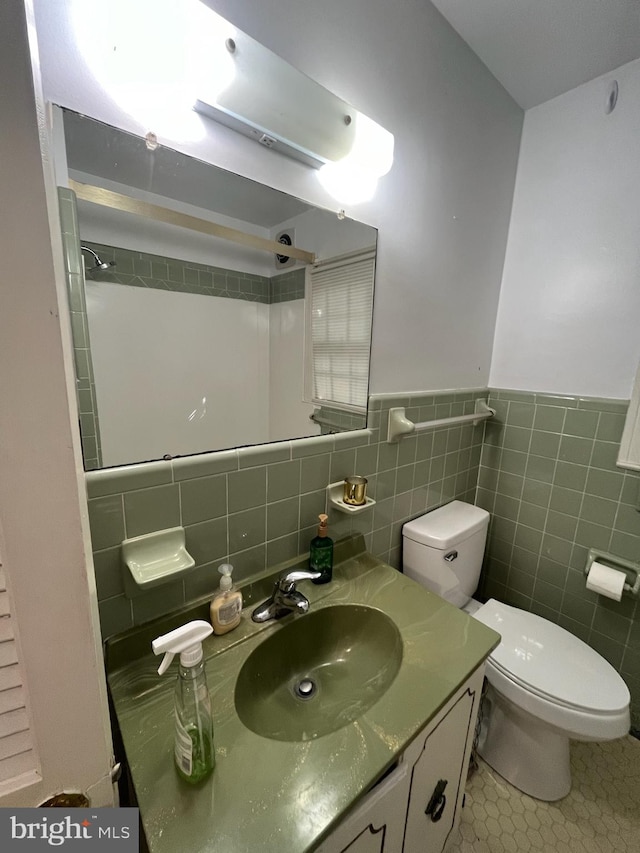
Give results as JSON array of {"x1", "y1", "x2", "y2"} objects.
[{"x1": 473, "y1": 599, "x2": 630, "y2": 740}]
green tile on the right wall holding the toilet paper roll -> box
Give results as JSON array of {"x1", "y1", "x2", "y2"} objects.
[{"x1": 476, "y1": 389, "x2": 640, "y2": 728}]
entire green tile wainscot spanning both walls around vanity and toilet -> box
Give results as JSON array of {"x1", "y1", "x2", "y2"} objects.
[{"x1": 86, "y1": 382, "x2": 640, "y2": 728}]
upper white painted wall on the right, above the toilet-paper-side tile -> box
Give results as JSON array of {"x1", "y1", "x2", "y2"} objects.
[{"x1": 490, "y1": 61, "x2": 640, "y2": 399}]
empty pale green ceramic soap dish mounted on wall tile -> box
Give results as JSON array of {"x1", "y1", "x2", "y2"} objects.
[{"x1": 122, "y1": 527, "x2": 196, "y2": 594}]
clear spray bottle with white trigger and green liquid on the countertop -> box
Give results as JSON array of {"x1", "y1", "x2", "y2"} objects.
[{"x1": 151, "y1": 619, "x2": 215, "y2": 785}]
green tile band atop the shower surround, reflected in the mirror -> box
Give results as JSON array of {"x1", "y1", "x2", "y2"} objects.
[{"x1": 84, "y1": 240, "x2": 305, "y2": 304}]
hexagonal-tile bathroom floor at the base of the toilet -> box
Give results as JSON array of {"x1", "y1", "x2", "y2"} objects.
[{"x1": 449, "y1": 736, "x2": 640, "y2": 853}]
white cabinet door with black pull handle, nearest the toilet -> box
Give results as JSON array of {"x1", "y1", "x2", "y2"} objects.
[{"x1": 402, "y1": 689, "x2": 476, "y2": 853}]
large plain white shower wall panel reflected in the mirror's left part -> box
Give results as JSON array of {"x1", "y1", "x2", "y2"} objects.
[{"x1": 86, "y1": 281, "x2": 269, "y2": 466}]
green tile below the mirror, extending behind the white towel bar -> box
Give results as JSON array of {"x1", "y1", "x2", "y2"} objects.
[{"x1": 86, "y1": 389, "x2": 487, "y2": 637}]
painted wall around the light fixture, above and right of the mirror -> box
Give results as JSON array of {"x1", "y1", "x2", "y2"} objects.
[{"x1": 36, "y1": 0, "x2": 522, "y2": 392}]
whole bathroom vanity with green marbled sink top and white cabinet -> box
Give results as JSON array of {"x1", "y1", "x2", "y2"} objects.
[{"x1": 106, "y1": 536, "x2": 500, "y2": 853}]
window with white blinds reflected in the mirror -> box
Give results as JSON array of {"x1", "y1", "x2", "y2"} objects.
[{"x1": 307, "y1": 249, "x2": 375, "y2": 412}]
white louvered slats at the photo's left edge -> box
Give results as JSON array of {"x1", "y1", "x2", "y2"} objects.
[{"x1": 0, "y1": 566, "x2": 37, "y2": 791}]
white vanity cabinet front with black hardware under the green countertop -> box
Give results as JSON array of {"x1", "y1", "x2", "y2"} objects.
[{"x1": 316, "y1": 664, "x2": 484, "y2": 853}]
